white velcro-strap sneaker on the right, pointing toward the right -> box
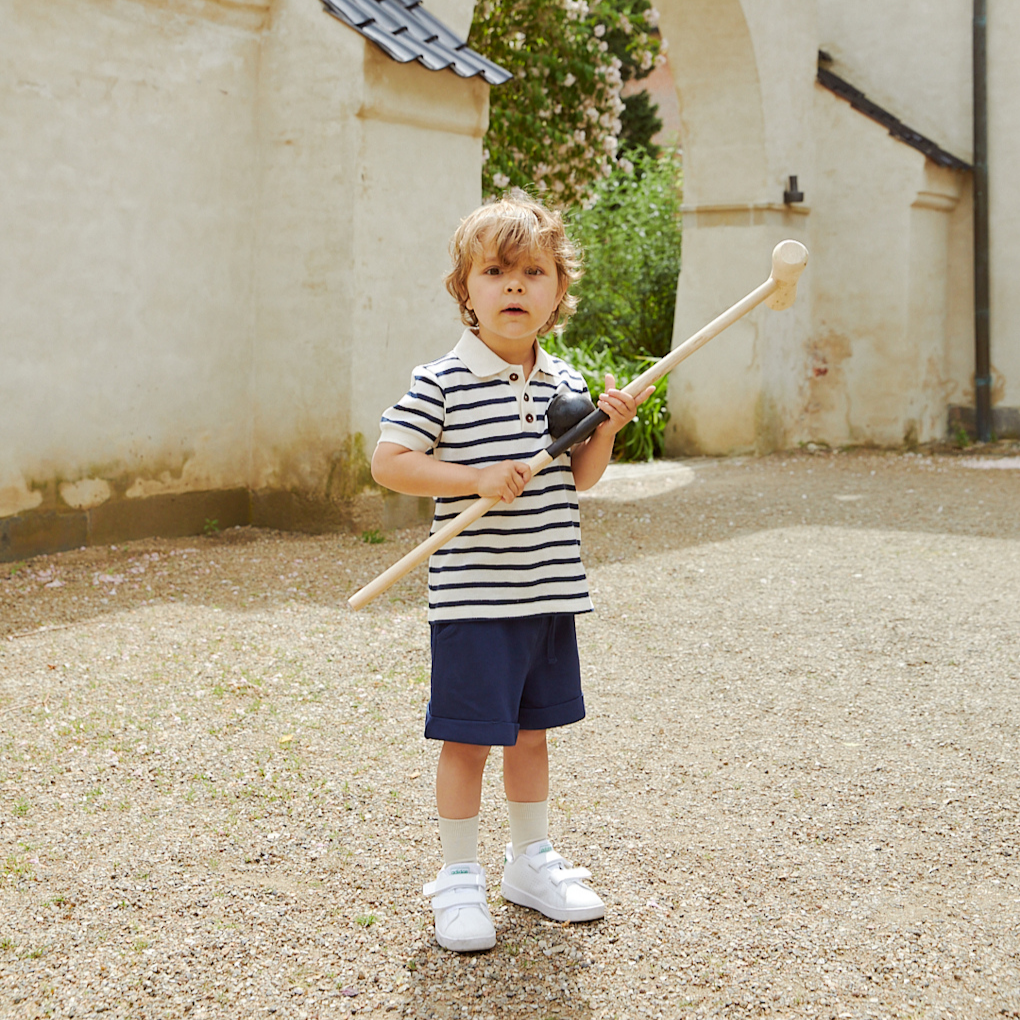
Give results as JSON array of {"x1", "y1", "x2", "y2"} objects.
[{"x1": 501, "y1": 839, "x2": 606, "y2": 921}]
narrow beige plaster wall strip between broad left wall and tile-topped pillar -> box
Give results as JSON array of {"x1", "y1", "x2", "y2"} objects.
[{"x1": 244, "y1": 0, "x2": 365, "y2": 501}]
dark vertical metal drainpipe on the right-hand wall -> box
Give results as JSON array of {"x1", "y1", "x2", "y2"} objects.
[{"x1": 974, "y1": 0, "x2": 991, "y2": 443}]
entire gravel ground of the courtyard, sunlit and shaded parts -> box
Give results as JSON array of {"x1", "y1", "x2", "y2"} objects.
[{"x1": 0, "y1": 446, "x2": 1020, "y2": 1020}]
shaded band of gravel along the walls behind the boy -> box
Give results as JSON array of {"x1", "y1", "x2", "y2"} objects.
[{"x1": 0, "y1": 451, "x2": 1020, "y2": 635}]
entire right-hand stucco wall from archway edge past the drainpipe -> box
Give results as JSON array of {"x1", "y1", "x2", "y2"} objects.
[{"x1": 660, "y1": 0, "x2": 1003, "y2": 453}]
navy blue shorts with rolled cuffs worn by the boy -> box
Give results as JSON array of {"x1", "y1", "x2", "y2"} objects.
[{"x1": 425, "y1": 613, "x2": 584, "y2": 747}]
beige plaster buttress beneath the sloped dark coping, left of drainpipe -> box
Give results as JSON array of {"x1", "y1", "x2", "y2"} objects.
[{"x1": 805, "y1": 87, "x2": 961, "y2": 445}]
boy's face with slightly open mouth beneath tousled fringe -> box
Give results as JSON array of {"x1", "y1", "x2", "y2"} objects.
[{"x1": 467, "y1": 244, "x2": 566, "y2": 360}]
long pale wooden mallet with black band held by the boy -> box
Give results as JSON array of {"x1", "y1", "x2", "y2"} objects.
[{"x1": 348, "y1": 241, "x2": 808, "y2": 609}]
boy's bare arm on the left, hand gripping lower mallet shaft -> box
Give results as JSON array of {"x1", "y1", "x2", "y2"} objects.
[{"x1": 372, "y1": 443, "x2": 534, "y2": 503}]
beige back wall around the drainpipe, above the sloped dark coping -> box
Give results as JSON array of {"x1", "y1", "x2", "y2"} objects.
[{"x1": 819, "y1": 0, "x2": 1020, "y2": 416}]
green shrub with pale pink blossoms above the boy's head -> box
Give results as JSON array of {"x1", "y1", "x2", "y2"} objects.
[{"x1": 470, "y1": 0, "x2": 664, "y2": 206}]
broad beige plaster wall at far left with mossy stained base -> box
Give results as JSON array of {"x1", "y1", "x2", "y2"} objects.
[{"x1": 0, "y1": 0, "x2": 264, "y2": 516}]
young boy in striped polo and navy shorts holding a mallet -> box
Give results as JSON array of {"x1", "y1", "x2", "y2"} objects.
[{"x1": 372, "y1": 192, "x2": 652, "y2": 952}]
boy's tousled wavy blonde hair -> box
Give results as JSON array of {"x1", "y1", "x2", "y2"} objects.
[{"x1": 444, "y1": 188, "x2": 582, "y2": 334}]
